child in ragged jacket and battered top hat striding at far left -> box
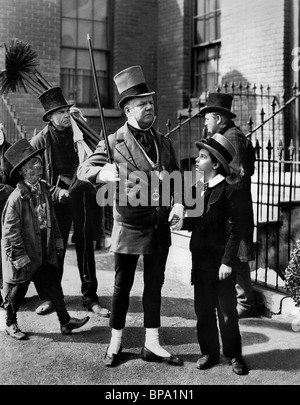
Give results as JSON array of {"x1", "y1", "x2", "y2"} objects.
[{"x1": 2, "y1": 138, "x2": 89, "y2": 340}]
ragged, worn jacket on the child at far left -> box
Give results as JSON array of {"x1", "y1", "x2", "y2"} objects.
[{"x1": 2, "y1": 181, "x2": 63, "y2": 284}]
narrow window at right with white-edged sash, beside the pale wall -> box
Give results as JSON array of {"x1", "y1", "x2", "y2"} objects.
[{"x1": 192, "y1": 0, "x2": 221, "y2": 97}]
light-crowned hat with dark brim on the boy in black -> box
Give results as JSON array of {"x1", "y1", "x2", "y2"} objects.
[{"x1": 196, "y1": 132, "x2": 236, "y2": 176}]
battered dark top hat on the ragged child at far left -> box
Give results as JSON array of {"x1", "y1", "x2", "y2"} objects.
[{"x1": 4, "y1": 138, "x2": 46, "y2": 181}]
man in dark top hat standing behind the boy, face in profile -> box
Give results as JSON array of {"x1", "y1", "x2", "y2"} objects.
[{"x1": 200, "y1": 93, "x2": 256, "y2": 318}]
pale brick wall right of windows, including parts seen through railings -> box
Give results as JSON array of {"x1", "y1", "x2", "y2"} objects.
[{"x1": 220, "y1": 0, "x2": 291, "y2": 144}]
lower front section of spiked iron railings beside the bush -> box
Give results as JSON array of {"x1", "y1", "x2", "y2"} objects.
[{"x1": 251, "y1": 141, "x2": 300, "y2": 290}]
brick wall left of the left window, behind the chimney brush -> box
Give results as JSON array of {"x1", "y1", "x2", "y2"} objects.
[{"x1": 0, "y1": 0, "x2": 60, "y2": 138}]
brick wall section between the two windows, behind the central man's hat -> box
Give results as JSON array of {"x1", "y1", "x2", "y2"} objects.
[{"x1": 113, "y1": 0, "x2": 189, "y2": 133}]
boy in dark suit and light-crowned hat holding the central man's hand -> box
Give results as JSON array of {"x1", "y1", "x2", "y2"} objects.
[{"x1": 184, "y1": 133, "x2": 248, "y2": 375}]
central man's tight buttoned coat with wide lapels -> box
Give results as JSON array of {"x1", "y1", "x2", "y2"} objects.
[{"x1": 77, "y1": 123, "x2": 182, "y2": 254}]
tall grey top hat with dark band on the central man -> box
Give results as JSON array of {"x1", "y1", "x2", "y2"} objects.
[{"x1": 114, "y1": 65, "x2": 155, "y2": 108}]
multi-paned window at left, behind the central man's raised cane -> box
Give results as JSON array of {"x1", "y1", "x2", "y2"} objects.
[{"x1": 61, "y1": 0, "x2": 112, "y2": 108}]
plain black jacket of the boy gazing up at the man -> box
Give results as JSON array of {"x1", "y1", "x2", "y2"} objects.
[{"x1": 183, "y1": 180, "x2": 241, "y2": 278}]
